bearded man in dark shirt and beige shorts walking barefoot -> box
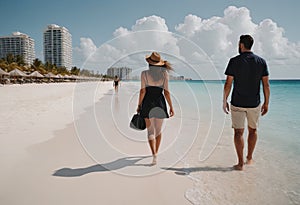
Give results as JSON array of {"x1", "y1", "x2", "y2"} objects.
[{"x1": 223, "y1": 35, "x2": 270, "y2": 170}]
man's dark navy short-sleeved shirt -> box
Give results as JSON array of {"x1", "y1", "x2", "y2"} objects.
[{"x1": 225, "y1": 52, "x2": 269, "y2": 108}]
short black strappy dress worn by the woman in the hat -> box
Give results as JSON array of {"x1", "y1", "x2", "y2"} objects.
[{"x1": 140, "y1": 71, "x2": 169, "y2": 119}]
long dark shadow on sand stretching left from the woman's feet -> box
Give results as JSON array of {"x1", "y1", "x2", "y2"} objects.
[{"x1": 52, "y1": 156, "x2": 149, "y2": 177}]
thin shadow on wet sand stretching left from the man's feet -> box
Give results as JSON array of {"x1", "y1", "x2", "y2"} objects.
[{"x1": 162, "y1": 166, "x2": 234, "y2": 175}]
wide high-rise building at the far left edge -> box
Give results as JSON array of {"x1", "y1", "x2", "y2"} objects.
[{"x1": 0, "y1": 32, "x2": 35, "y2": 64}]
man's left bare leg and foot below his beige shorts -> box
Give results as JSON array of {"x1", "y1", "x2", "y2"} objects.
[{"x1": 233, "y1": 129, "x2": 244, "y2": 170}]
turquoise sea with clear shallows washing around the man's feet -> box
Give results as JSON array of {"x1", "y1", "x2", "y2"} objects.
[{"x1": 166, "y1": 80, "x2": 300, "y2": 204}]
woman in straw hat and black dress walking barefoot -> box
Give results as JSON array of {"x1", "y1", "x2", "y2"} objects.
[{"x1": 137, "y1": 52, "x2": 174, "y2": 165}]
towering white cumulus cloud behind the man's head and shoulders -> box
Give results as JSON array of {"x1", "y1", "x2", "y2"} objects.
[{"x1": 175, "y1": 6, "x2": 300, "y2": 78}]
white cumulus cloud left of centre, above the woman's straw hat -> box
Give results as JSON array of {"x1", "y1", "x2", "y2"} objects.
[{"x1": 74, "y1": 16, "x2": 179, "y2": 73}]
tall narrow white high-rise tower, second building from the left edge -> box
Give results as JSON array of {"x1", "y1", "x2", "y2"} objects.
[{"x1": 44, "y1": 24, "x2": 72, "y2": 69}]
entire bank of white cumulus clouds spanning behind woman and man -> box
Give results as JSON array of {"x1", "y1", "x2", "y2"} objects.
[{"x1": 74, "y1": 6, "x2": 300, "y2": 79}]
